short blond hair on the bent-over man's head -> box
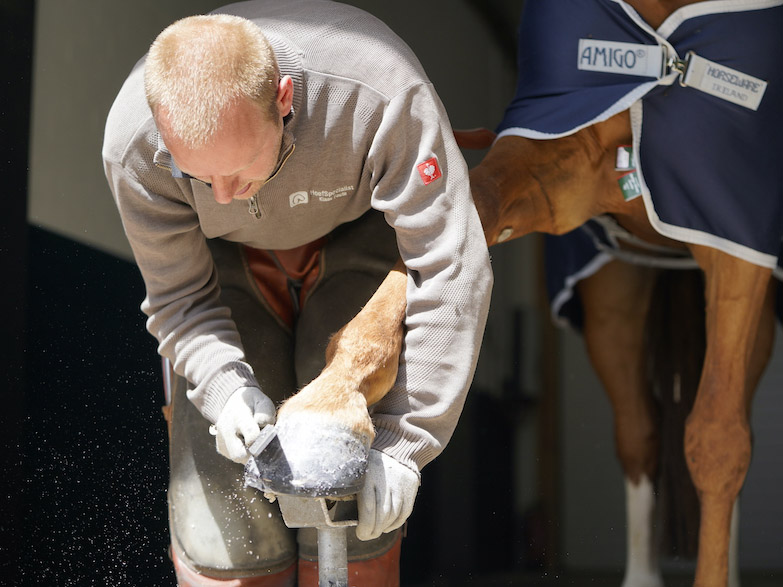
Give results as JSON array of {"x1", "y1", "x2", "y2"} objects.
[{"x1": 144, "y1": 14, "x2": 280, "y2": 147}]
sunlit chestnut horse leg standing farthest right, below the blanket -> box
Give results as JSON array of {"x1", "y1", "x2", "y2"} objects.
[{"x1": 685, "y1": 246, "x2": 771, "y2": 587}]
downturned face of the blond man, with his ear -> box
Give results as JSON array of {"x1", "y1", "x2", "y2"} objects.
[{"x1": 157, "y1": 78, "x2": 291, "y2": 204}]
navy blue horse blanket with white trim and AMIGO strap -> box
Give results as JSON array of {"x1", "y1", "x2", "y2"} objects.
[{"x1": 498, "y1": 0, "x2": 783, "y2": 326}]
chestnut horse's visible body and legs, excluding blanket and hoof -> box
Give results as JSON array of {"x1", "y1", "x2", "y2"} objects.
[{"x1": 280, "y1": 0, "x2": 781, "y2": 587}]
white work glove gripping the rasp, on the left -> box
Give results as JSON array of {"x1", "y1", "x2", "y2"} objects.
[{"x1": 210, "y1": 387, "x2": 275, "y2": 465}]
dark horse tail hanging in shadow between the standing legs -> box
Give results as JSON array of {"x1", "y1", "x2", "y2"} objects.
[{"x1": 646, "y1": 270, "x2": 706, "y2": 558}]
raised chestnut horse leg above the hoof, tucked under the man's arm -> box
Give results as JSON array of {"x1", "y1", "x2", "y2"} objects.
[{"x1": 278, "y1": 261, "x2": 407, "y2": 446}]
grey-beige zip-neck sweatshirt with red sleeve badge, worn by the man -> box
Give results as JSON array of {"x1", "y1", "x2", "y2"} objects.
[{"x1": 103, "y1": 0, "x2": 492, "y2": 470}]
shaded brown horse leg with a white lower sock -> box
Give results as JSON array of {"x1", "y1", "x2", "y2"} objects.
[{"x1": 579, "y1": 261, "x2": 663, "y2": 587}]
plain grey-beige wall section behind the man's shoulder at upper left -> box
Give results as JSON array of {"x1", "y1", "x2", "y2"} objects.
[{"x1": 28, "y1": 0, "x2": 220, "y2": 258}]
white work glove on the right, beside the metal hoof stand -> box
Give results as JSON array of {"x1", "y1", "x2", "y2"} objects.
[{"x1": 356, "y1": 449, "x2": 419, "y2": 540}]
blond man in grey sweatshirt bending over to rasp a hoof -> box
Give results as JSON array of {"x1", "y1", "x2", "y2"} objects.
[{"x1": 103, "y1": 0, "x2": 492, "y2": 586}]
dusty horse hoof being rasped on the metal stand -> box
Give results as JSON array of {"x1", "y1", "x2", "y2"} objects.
[{"x1": 246, "y1": 413, "x2": 370, "y2": 497}]
